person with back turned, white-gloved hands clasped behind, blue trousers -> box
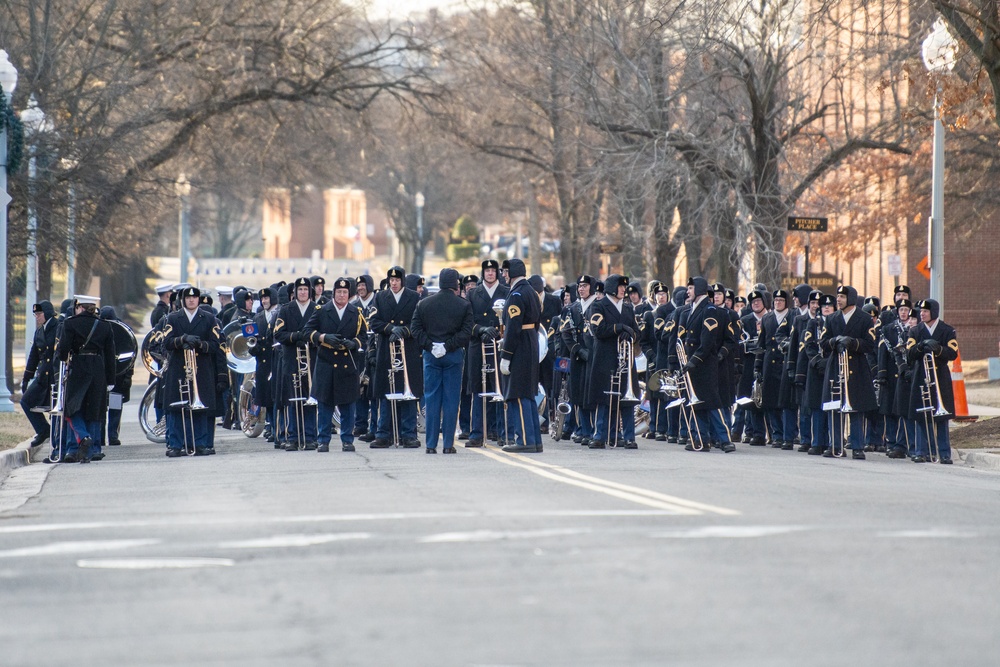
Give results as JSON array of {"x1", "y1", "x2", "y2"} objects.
[{"x1": 410, "y1": 269, "x2": 473, "y2": 454}]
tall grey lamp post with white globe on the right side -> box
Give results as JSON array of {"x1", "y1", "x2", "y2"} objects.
[{"x1": 921, "y1": 17, "x2": 955, "y2": 317}]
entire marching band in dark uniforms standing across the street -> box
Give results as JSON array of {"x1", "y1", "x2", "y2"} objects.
[{"x1": 21, "y1": 259, "x2": 958, "y2": 464}]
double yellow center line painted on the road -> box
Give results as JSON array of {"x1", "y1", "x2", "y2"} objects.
[{"x1": 474, "y1": 445, "x2": 740, "y2": 516}]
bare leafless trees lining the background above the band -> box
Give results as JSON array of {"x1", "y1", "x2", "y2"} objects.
[{"x1": 0, "y1": 0, "x2": 992, "y2": 300}]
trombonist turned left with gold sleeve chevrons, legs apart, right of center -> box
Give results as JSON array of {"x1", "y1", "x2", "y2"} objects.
[{"x1": 681, "y1": 276, "x2": 736, "y2": 454}]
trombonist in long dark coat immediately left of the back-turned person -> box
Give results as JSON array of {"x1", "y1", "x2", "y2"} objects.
[{"x1": 369, "y1": 266, "x2": 424, "y2": 449}]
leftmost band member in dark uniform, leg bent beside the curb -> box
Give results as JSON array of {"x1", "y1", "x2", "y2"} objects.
[{"x1": 21, "y1": 301, "x2": 59, "y2": 447}]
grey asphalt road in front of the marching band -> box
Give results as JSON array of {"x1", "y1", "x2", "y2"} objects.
[{"x1": 0, "y1": 410, "x2": 1000, "y2": 667}]
